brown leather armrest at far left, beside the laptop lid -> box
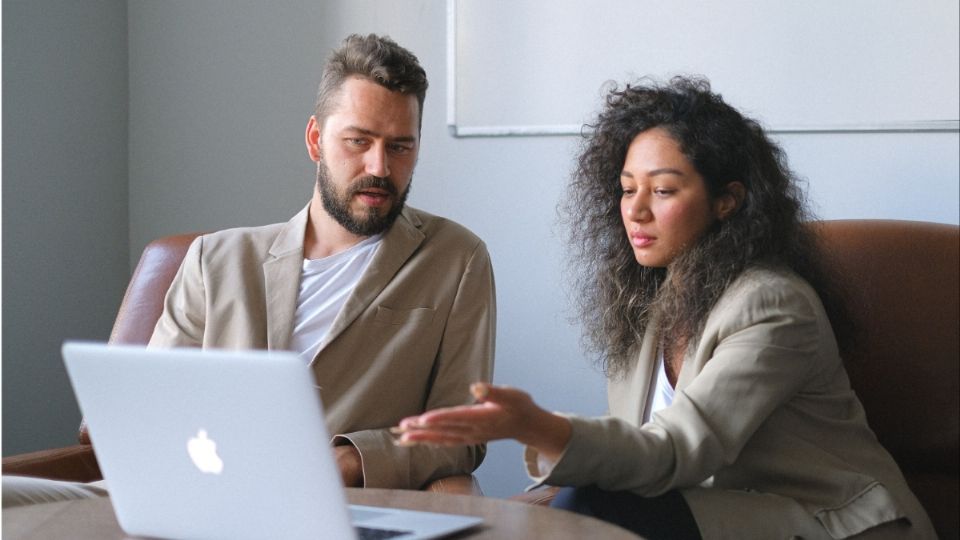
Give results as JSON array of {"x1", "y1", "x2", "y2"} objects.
[{"x1": 3, "y1": 444, "x2": 103, "y2": 482}]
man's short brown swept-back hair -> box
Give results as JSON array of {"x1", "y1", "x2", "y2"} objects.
[{"x1": 314, "y1": 34, "x2": 427, "y2": 130}]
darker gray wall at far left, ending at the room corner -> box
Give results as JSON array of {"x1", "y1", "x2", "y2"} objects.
[{"x1": 3, "y1": 0, "x2": 129, "y2": 455}]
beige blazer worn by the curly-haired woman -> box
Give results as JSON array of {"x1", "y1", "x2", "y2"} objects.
[{"x1": 526, "y1": 270, "x2": 935, "y2": 539}]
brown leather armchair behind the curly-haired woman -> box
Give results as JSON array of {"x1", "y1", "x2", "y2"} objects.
[{"x1": 513, "y1": 220, "x2": 960, "y2": 539}]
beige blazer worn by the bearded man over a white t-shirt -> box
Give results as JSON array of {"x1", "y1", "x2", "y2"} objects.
[{"x1": 150, "y1": 205, "x2": 496, "y2": 488}]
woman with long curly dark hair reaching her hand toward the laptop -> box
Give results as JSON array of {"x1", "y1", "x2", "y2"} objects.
[{"x1": 397, "y1": 78, "x2": 935, "y2": 539}]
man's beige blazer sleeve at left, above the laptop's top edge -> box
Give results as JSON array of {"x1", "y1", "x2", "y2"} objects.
[{"x1": 148, "y1": 236, "x2": 207, "y2": 347}]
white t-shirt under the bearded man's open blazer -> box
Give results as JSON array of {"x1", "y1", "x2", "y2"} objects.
[{"x1": 290, "y1": 234, "x2": 383, "y2": 363}]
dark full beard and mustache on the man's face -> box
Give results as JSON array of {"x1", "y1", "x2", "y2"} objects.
[{"x1": 317, "y1": 161, "x2": 413, "y2": 236}]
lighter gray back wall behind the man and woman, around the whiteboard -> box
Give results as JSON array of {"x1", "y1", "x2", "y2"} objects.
[{"x1": 4, "y1": 0, "x2": 960, "y2": 496}]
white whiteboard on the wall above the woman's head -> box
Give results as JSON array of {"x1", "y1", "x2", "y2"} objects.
[{"x1": 447, "y1": 0, "x2": 960, "y2": 136}]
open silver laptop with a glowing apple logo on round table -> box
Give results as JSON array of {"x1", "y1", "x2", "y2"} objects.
[{"x1": 63, "y1": 342, "x2": 482, "y2": 539}]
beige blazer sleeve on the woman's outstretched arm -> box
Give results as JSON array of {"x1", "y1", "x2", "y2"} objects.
[{"x1": 527, "y1": 278, "x2": 832, "y2": 496}]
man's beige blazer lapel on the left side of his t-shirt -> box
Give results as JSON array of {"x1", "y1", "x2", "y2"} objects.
[{"x1": 263, "y1": 204, "x2": 310, "y2": 350}]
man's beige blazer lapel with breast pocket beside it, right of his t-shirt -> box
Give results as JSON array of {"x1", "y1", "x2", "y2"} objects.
[{"x1": 314, "y1": 208, "x2": 425, "y2": 354}]
